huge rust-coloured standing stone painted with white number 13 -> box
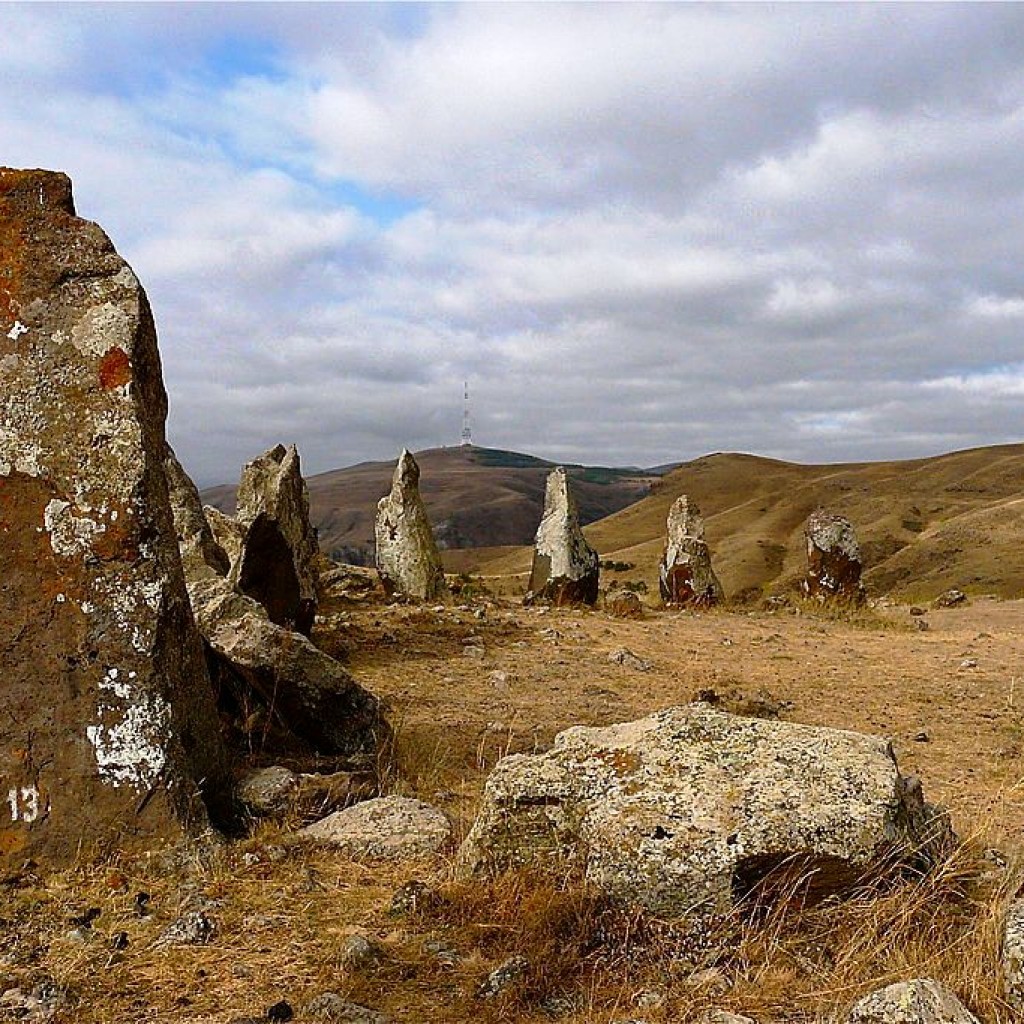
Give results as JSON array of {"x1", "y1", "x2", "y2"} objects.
[{"x1": 0, "y1": 169, "x2": 228, "y2": 867}]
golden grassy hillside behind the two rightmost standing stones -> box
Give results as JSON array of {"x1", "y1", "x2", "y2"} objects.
[{"x1": 471, "y1": 444, "x2": 1024, "y2": 597}]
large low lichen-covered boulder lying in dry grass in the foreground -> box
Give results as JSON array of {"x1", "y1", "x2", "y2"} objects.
[{"x1": 459, "y1": 705, "x2": 948, "y2": 920}]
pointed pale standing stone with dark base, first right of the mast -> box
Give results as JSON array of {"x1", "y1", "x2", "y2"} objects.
[{"x1": 526, "y1": 466, "x2": 601, "y2": 606}]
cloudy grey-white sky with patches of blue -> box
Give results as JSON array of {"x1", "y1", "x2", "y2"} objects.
[{"x1": 6, "y1": 3, "x2": 1024, "y2": 484}]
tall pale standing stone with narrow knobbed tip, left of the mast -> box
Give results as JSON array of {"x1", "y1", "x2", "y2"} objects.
[{"x1": 375, "y1": 449, "x2": 449, "y2": 601}]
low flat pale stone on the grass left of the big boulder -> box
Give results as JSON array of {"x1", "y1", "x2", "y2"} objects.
[{"x1": 299, "y1": 797, "x2": 452, "y2": 860}]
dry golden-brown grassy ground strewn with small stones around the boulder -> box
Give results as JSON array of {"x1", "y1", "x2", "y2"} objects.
[{"x1": 0, "y1": 596, "x2": 1024, "y2": 1024}]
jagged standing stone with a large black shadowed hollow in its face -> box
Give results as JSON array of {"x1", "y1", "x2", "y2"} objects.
[{"x1": 231, "y1": 444, "x2": 319, "y2": 636}]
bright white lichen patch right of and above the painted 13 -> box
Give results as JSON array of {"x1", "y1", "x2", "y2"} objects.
[{"x1": 85, "y1": 669, "x2": 171, "y2": 791}]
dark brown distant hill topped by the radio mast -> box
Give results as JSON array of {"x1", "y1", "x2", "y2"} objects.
[{"x1": 203, "y1": 447, "x2": 658, "y2": 564}]
